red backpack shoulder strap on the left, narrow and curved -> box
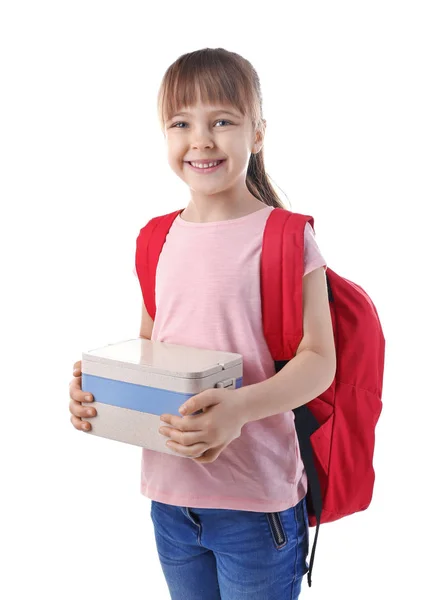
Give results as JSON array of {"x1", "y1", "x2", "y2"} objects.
[{"x1": 135, "y1": 209, "x2": 183, "y2": 320}]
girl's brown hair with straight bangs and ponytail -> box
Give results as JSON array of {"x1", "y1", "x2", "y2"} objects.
[{"x1": 157, "y1": 48, "x2": 285, "y2": 208}]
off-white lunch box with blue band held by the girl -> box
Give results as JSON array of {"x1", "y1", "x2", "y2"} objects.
[{"x1": 81, "y1": 338, "x2": 243, "y2": 456}]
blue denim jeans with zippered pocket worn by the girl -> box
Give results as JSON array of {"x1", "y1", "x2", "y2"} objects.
[{"x1": 151, "y1": 499, "x2": 309, "y2": 600}]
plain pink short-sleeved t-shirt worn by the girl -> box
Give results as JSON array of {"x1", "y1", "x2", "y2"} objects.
[{"x1": 133, "y1": 206, "x2": 326, "y2": 512}]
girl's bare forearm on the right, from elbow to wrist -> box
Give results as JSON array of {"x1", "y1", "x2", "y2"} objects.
[{"x1": 236, "y1": 349, "x2": 336, "y2": 422}]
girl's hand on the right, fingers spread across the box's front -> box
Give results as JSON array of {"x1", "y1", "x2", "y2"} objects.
[{"x1": 159, "y1": 388, "x2": 247, "y2": 463}]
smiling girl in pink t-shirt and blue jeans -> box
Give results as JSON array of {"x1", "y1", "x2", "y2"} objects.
[{"x1": 70, "y1": 48, "x2": 336, "y2": 600}]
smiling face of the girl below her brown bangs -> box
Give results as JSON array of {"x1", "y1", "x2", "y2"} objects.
[{"x1": 165, "y1": 103, "x2": 263, "y2": 196}]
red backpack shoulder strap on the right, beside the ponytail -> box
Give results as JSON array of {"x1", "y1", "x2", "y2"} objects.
[{"x1": 260, "y1": 208, "x2": 314, "y2": 361}]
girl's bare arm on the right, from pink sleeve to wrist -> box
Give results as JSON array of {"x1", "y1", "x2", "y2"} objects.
[{"x1": 236, "y1": 267, "x2": 336, "y2": 422}]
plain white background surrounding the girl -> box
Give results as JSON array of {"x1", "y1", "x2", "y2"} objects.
[{"x1": 0, "y1": 0, "x2": 448, "y2": 600}]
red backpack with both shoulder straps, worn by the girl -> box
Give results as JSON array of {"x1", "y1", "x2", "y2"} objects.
[{"x1": 135, "y1": 208, "x2": 385, "y2": 586}]
